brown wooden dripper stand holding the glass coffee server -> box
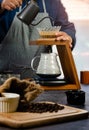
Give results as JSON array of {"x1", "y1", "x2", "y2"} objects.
[{"x1": 30, "y1": 31, "x2": 80, "y2": 90}]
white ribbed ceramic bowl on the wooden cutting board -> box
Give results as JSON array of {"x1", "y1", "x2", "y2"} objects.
[{"x1": 0, "y1": 93, "x2": 20, "y2": 112}]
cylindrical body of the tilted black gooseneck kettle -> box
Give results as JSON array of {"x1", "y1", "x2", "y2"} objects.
[{"x1": 17, "y1": 0, "x2": 40, "y2": 25}]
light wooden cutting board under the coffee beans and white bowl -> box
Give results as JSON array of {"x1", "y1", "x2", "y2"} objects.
[{"x1": 0, "y1": 104, "x2": 88, "y2": 128}]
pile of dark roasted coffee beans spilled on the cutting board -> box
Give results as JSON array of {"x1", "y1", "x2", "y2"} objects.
[{"x1": 17, "y1": 102, "x2": 64, "y2": 113}]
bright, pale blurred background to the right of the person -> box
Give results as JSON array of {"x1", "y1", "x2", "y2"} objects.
[{"x1": 53, "y1": 0, "x2": 89, "y2": 79}]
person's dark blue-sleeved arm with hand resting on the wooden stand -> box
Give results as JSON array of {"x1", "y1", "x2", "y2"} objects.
[{"x1": 45, "y1": 0, "x2": 76, "y2": 49}]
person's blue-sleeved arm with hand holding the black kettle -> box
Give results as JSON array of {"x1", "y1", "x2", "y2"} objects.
[{"x1": 0, "y1": 0, "x2": 23, "y2": 44}]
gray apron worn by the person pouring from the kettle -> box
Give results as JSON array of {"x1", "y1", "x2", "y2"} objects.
[{"x1": 0, "y1": 0, "x2": 51, "y2": 78}]
